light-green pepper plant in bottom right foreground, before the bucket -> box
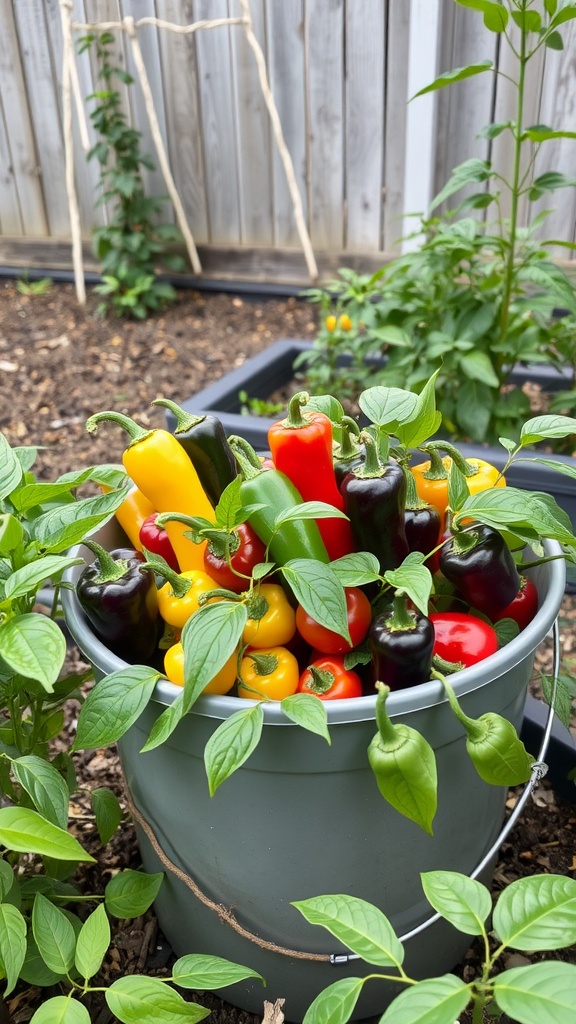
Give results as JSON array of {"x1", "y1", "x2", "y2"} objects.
[{"x1": 293, "y1": 870, "x2": 576, "y2": 1024}]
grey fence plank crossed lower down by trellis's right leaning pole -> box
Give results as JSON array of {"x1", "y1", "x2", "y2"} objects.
[{"x1": 266, "y1": 0, "x2": 307, "y2": 246}]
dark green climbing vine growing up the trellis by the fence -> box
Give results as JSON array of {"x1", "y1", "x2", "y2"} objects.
[{"x1": 80, "y1": 32, "x2": 183, "y2": 319}]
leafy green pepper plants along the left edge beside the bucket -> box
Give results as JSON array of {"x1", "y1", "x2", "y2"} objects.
[{"x1": 0, "y1": 433, "x2": 259, "y2": 1024}]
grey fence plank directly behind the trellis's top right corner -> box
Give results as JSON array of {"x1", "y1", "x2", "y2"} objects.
[{"x1": 226, "y1": 0, "x2": 273, "y2": 245}]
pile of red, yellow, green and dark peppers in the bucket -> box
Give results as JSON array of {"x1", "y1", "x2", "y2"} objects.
[{"x1": 77, "y1": 392, "x2": 538, "y2": 700}]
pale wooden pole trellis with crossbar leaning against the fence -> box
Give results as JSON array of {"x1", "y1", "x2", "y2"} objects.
[{"x1": 59, "y1": 0, "x2": 319, "y2": 304}]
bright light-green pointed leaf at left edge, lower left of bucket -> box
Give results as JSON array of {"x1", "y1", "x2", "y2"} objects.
[{"x1": 0, "y1": 807, "x2": 94, "y2": 862}]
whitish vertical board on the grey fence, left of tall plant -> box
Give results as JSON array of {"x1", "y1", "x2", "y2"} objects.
[{"x1": 380, "y1": 0, "x2": 411, "y2": 252}]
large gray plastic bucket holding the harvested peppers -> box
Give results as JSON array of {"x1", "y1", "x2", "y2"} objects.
[{"x1": 63, "y1": 524, "x2": 565, "y2": 1021}]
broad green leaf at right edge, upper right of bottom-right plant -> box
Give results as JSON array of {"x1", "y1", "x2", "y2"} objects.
[{"x1": 493, "y1": 874, "x2": 576, "y2": 950}]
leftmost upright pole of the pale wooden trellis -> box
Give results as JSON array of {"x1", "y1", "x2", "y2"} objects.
[{"x1": 60, "y1": 0, "x2": 86, "y2": 305}]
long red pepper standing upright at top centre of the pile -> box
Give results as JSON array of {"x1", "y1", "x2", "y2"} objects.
[{"x1": 268, "y1": 391, "x2": 354, "y2": 561}]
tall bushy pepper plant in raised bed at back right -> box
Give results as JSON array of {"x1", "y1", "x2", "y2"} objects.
[{"x1": 295, "y1": 0, "x2": 576, "y2": 442}]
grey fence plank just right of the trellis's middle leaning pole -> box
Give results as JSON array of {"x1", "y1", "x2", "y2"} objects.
[{"x1": 156, "y1": 0, "x2": 208, "y2": 243}]
